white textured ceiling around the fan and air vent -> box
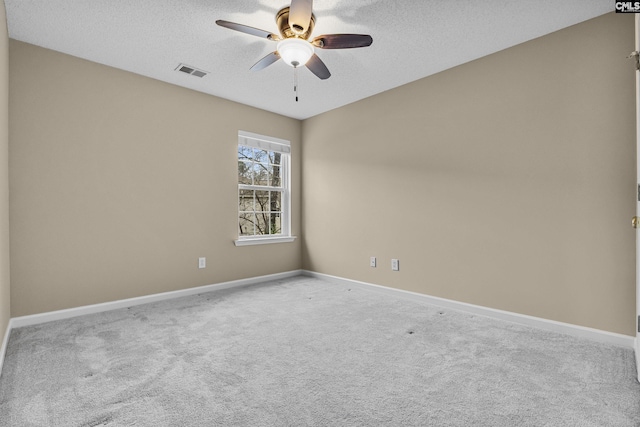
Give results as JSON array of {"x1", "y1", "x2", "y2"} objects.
[{"x1": 5, "y1": 0, "x2": 614, "y2": 119}]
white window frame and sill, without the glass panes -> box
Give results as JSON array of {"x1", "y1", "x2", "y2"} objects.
[{"x1": 234, "y1": 131, "x2": 296, "y2": 246}]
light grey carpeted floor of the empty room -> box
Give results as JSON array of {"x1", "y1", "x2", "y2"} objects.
[{"x1": 0, "y1": 277, "x2": 640, "y2": 427}]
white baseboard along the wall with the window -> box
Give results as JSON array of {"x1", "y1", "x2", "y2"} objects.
[{"x1": 7, "y1": 270, "x2": 302, "y2": 330}]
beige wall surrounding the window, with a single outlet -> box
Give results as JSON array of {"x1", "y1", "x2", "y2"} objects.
[{"x1": 10, "y1": 40, "x2": 301, "y2": 316}]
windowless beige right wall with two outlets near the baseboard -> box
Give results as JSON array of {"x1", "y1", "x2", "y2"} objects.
[{"x1": 302, "y1": 13, "x2": 635, "y2": 335}]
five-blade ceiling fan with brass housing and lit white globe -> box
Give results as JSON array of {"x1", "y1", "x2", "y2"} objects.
[{"x1": 216, "y1": 0, "x2": 373, "y2": 80}]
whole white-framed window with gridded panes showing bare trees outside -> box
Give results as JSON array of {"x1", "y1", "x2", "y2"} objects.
[{"x1": 235, "y1": 131, "x2": 295, "y2": 246}]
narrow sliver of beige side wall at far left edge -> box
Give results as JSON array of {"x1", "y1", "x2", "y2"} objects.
[{"x1": 0, "y1": 1, "x2": 11, "y2": 345}]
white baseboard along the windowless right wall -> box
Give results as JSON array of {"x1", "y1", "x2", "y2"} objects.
[{"x1": 303, "y1": 270, "x2": 640, "y2": 350}]
